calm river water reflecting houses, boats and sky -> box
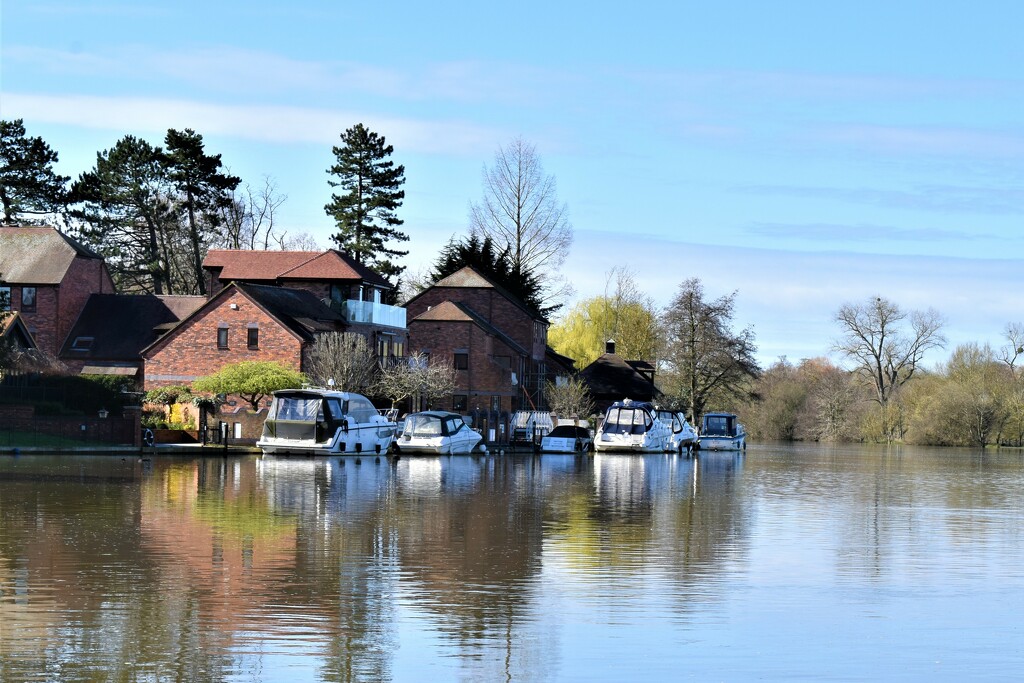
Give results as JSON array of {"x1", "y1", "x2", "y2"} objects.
[{"x1": 0, "y1": 444, "x2": 1024, "y2": 682}]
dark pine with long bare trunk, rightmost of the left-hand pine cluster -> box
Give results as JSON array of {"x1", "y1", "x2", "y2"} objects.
[{"x1": 162, "y1": 128, "x2": 242, "y2": 294}]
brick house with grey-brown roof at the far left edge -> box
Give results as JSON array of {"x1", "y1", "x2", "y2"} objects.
[{"x1": 0, "y1": 225, "x2": 115, "y2": 357}]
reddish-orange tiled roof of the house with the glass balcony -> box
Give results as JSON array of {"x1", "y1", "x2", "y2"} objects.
[{"x1": 203, "y1": 249, "x2": 392, "y2": 289}]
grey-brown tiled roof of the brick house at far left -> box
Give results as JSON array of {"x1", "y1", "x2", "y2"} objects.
[{"x1": 0, "y1": 225, "x2": 101, "y2": 285}]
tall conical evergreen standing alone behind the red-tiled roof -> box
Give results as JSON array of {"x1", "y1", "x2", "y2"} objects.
[{"x1": 324, "y1": 123, "x2": 409, "y2": 278}]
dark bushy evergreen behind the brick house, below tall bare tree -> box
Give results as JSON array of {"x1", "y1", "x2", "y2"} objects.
[{"x1": 430, "y1": 232, "x2": 559, "y2": 317}]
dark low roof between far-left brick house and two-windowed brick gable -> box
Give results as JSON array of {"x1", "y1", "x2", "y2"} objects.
[{"x1": 59, "y1": 294, "x2": 206, "y2": 360}]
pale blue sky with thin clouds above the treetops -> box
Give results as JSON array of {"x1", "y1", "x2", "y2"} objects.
[{"x1": 0, "y1": 0, "x2": 1024, "y2": 365}]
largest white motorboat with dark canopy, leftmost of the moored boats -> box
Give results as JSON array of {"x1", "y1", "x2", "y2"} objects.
[{"x1": 256, "y1": 388, "x2": 398, "y2": 456}]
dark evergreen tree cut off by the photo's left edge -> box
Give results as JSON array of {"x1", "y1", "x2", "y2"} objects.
[{"x1": 0, "y1": 119, "x2": 70, "y2": 223}]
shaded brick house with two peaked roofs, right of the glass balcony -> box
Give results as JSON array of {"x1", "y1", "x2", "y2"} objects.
[{"x1": 406, "y1": 266, "x2": 571, "y2": 416}]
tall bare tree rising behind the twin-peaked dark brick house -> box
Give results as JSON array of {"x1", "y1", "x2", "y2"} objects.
[{"x1": 470, "y1": 137, "x2": 572, "y2": 309}]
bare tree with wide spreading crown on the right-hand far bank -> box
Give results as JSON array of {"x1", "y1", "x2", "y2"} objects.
[{"x1": 834, "y1": 297, "x2": 946, "y2": 408}]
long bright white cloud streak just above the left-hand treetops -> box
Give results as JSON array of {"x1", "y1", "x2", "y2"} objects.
[{"x1": 4, "y1": 93, "x2": 508, "y2": 156}]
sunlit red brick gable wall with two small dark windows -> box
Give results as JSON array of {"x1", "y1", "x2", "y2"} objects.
[{"x1": 145, "y1": 290, "x2": 302, "y2": 390}]
